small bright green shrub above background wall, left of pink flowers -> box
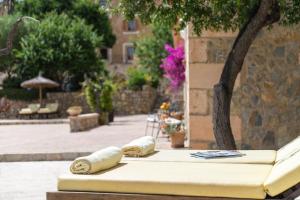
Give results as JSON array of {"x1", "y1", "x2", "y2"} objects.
[{"x1": 127, "y1": 67, "x2": 147, "y2": 90}]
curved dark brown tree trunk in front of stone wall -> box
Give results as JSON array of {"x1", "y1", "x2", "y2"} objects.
[{"x1": 213, "y1": 0, "x2": 280, "y2": 150}]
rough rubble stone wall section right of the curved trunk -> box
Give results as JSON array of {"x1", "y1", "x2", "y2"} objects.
[{"x1": 238, "y1": 25, "x2": 300, "y2": 149}]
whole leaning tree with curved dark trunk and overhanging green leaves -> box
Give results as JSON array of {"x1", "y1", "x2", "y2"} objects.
[{"x1": 118, "y1": 0, "x2": 300, "y2": 149}]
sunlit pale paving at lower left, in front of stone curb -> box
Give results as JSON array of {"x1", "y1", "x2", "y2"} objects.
[{"x1": 0, "y1": 161, "x2": 70, "y2": 200}]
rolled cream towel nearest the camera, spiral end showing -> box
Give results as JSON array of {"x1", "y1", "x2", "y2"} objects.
[{"x1": 70, "y1": 147, "x2": 123, "y2": 174}]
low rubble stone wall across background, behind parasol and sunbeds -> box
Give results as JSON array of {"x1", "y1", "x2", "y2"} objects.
[{"x1": 0, "y1": 87, "x2": 157, "y2": 119}]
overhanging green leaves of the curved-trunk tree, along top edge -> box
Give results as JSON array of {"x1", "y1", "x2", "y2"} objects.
[{"x1": 118, "y1": 0, "x2": 300, "y2": 34}]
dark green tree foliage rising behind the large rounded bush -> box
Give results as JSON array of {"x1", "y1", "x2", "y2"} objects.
[{"x1": 15, "y1": 0, "x2": 116, "y2": 47}]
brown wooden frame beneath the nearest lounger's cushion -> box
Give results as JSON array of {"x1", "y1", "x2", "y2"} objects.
[{"x1": 47, "y1": 183, "x2": 300, "y2": 200}]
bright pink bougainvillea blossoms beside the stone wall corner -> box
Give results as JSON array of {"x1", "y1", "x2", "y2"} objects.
[{"x1": 161, "y1": 44, "x2": 185, "y2": 91}]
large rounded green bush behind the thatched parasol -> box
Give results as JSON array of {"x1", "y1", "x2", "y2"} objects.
[{"x1": 15, "y1": 13, "x2": 105, "y2": 87}]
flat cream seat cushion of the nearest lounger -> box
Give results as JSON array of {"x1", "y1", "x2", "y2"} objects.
[{"x1": 58, "y1": 161, "x2": 272, "y2": 199}]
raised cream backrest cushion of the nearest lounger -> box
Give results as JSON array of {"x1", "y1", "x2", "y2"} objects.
[{"x1": 264, "y1": 151, "x2": 300, "y2": 196}]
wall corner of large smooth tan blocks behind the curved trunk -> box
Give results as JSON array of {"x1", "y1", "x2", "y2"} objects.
[{"x1": 186, "y1": 29, "x2": 241, "y2": 149}]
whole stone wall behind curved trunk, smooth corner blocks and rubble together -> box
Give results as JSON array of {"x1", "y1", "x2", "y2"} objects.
[{"x1": 187, "y1": 25, "x2": 300, "y2": 149}]
